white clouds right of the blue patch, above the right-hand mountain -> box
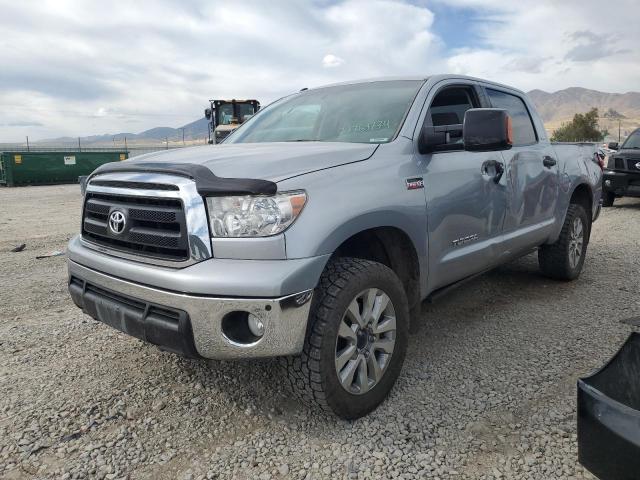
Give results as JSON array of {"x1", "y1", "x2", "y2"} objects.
[{"x1": 447, "y1": 0, "x2": 640, "y2": 92}]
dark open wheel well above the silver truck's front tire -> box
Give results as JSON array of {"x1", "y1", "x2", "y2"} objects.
[{"x1": 333, "y1": 227, "x2": 420, "y2": 307}]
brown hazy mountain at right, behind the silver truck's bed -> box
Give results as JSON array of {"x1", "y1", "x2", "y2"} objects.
[{"x1": 528, "y1": 87, "x2": 640, "y2": 139}]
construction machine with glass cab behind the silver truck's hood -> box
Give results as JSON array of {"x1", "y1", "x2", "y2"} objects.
[{"x1": 204, "y1": 99, "x2": 260, "y2": 143}]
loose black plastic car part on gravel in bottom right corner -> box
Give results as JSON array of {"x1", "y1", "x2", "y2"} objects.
[{"x1": 578, "y1": 333, "x2": 640, "y2": 480}]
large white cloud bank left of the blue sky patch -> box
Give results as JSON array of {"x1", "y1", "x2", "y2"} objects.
[{"x1": 0, "y1": 0, "x2": 439, "y2": 142}]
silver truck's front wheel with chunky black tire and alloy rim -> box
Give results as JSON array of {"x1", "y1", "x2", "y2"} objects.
[{"x1": 282, "y1": 257, "x2": 409, "y2": 420}]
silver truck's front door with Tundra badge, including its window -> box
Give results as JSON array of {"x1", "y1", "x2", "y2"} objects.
[{"x1": 418, "y1": 80, "x2": 506, "y2": 290}]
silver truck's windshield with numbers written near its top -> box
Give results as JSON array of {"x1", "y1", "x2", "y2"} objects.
[{"x1": 225, "y1": 80, "x2": 423, "y2": 143}]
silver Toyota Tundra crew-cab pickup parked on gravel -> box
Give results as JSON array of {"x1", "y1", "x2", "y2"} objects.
[{"x1": 68, "y1": 75, "x2": 602, "y2": 418}]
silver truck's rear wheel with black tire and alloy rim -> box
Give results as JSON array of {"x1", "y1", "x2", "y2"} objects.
[{"x1": 538, "y1": 203, "x2": 591, "y2": 280}]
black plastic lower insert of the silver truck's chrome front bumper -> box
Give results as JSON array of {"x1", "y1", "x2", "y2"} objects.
[{"x1": 69, "y1": 277, "x2": 200, "y2": 358}]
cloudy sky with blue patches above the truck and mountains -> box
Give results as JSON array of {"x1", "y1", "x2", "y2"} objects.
[{"x1": 0, "y1": 0, "x2": 640, "y2": 142}]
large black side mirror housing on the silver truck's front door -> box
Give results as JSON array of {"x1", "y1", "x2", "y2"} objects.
[{"x1": 462, "y1": 108, "x2": 513, "y2": 152}]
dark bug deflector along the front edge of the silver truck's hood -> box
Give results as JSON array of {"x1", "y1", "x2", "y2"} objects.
[{"x1": 91, "y1": 161, "x2": 278, "y2": 196}]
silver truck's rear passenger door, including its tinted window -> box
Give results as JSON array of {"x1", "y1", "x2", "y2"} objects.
[{"x1": 484, "y1": 86, "x2": 558, "y2": 256}]
